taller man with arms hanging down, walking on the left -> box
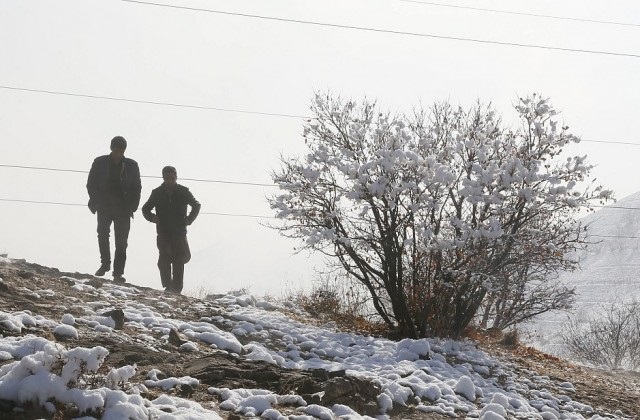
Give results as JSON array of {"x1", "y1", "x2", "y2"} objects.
[{"x1": 87, "y1": 136, "x2": 142, "y2": 283}]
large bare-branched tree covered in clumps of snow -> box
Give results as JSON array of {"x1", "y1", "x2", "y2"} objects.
[{"x1": 269, "y1": 95, "x2": 611, "y2": 337}]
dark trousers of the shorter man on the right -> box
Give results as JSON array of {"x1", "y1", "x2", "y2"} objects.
[{"x1": 157, "y1": 233, "x2": 191, "y2": 293}]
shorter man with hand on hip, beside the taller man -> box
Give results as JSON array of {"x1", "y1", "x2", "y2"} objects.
[{"x1": 142, "y1": 166, "x2": 200, "y2": 294}]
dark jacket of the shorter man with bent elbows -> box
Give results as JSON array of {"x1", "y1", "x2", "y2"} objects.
[{"x1": 142, "y1": 184, "x2": 200, "y2": 235}]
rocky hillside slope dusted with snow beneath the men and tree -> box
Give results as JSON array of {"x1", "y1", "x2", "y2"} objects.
[{"x1": 0, "y1": 257, "x2": 640, "y2": 420}]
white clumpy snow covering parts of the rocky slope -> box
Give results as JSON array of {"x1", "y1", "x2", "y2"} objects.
[{"x1": 0, "y1": 260, "x2": 624, "y2": 420}]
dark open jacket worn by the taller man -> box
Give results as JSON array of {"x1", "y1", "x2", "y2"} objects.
[{"x1": 87, "y1": 155, "x2": 142, "y2": 215}]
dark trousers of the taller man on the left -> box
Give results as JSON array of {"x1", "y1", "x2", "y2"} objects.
[{"x1": 98, "y1": 209, "x2": 131, "y2": 276}]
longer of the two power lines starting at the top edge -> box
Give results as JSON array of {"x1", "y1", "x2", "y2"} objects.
[{"x1": 120, "y1": 0, "x2": 640, "y2": 58}]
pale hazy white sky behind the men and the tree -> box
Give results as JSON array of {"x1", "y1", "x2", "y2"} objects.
[{"x1": 0, "y1": 0, "x2": 640, "y2": 295}]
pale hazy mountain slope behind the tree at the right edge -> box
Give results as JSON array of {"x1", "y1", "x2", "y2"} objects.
[{"x1": 528, "y1": 192, "x2": 640, "y2": 355}]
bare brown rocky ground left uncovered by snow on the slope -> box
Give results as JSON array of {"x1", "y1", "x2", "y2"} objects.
[{"x1": 0, "y1": 259, "x2": 640, "y2": 419}]
